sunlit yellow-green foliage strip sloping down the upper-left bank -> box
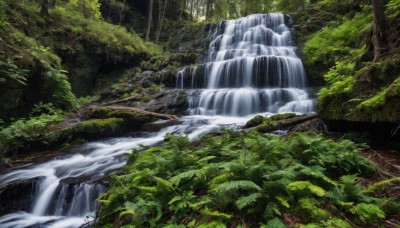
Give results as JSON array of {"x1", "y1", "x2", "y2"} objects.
[{"x1": 52, "y1": 0, "x2": 161, "y2": 61}]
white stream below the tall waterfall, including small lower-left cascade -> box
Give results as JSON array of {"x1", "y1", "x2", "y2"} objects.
[{"x1": 0, "y1": 116, "x2": 252, "y2": 228}]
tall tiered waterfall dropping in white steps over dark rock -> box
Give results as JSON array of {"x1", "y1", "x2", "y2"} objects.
[{"x1": 176, "y1": 13, "x2": 315, "y2": 116}]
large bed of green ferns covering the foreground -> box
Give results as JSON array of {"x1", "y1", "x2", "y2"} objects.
[{"x1": 97, "y1": 131, "x2": 394, "y2": 227}]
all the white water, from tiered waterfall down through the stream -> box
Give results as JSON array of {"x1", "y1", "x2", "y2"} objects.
[{"x1": 0, "y1": 14, "x2": 314, "y2": 228}]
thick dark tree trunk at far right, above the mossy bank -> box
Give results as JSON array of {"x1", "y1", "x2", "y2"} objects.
[{"x1": 372, "y1": 0, "x2": 388, "y2": 62}]
